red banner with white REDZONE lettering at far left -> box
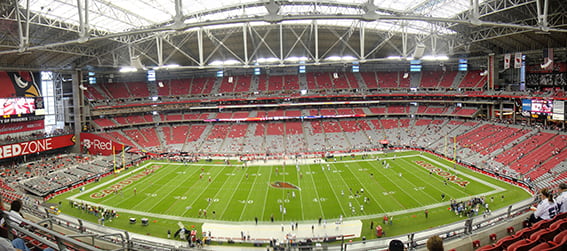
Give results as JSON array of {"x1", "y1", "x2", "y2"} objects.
[{"x1": 0, "y1": 135, "x2": 75, "y2": 159}]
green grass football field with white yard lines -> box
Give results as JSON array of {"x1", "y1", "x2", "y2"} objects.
[{"x1": 52, "y1": 151, "x2": 530, "y2": 241}]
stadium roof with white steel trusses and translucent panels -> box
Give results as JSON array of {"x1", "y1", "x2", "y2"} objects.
[{"x1": 0, "y1": 0, "x2": 567, "y2": 69}]
